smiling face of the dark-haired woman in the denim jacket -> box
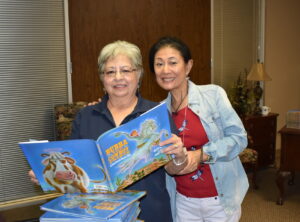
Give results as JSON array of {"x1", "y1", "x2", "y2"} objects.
[{"x1": 154, "y1": 46, "x2": 193, "y2": 91}]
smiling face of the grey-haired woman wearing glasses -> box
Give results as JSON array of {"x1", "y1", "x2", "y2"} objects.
[{"x1": 101, "y1": 54, "x2": 140, "y2": 99}]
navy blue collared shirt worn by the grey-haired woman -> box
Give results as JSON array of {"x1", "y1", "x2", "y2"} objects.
[{"x1": 71, "y1": 95, "x2": 175, "y2": 222}]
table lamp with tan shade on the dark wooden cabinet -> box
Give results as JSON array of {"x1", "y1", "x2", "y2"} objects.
[{"x1": 247, "y1": 61, "x2": 272, "y2": 115}]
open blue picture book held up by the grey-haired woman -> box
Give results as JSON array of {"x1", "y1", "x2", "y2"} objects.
[{"x1": 19, "y1": 103, "x2": 171, "y2": 193}]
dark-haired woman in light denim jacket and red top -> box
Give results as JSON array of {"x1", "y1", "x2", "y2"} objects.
[{"x1": 149, "y1": 37, "x2": 249, "y2": 222}]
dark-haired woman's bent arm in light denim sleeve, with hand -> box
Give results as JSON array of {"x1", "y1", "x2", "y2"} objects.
[{"x1": 178, "y1": 87, "x2": 247, "y2": 175}]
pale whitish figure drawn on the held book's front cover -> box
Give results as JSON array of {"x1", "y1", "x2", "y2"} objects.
[{"x1": 115, "y1": 119, "x2": 169, "y2": 172}]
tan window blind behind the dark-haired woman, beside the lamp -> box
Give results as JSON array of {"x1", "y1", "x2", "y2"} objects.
[{"x1": 212, "y1": 0, "x2": 259, "y2": 89}]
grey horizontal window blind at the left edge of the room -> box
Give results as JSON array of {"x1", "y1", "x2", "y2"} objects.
[{"x1": 0, "y1": 0, "x2": 68, "y2": 203}]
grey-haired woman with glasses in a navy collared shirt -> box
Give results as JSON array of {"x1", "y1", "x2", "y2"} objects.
[{"x1": 71, "y1": 41, "x2": 185, "y2": 222}]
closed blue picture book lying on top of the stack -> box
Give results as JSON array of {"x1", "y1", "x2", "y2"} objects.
[{"x1": 40, "y1": 191, "x2": 146, "y2": 220}]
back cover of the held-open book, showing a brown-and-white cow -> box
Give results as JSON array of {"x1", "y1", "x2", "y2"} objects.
[{"x1": 19, "y1": 139, "x2": 109, "y2": 193}]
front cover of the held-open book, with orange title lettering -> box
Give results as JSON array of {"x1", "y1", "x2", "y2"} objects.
[{"x1": 97, "y1": 103, "x2": 171, "y2": 191}]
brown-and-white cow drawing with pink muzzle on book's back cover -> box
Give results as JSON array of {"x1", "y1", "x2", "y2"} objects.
[{"x1": 41, "y1": 152, "x2": 106, "y2": 193}]
